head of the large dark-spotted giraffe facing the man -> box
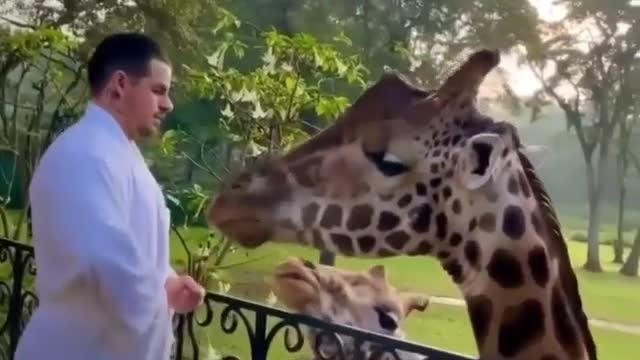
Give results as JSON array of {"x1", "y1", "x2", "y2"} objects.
[{"x1": 207, "y1": 51, "x2": 520, "y2": 258}]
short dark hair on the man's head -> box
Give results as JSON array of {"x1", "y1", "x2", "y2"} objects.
[{"x1": 87, "y1": 32, "x2": 169, "y2": 94}]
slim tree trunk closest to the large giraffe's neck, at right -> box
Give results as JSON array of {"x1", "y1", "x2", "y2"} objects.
[{"x1": 584, "y1": 158, "x2": 604, "y2": 272}]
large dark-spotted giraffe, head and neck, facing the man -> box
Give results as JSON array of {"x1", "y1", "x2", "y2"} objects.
[{"x1": 208, "y1": 50, "x2": 596, "y2": 360}]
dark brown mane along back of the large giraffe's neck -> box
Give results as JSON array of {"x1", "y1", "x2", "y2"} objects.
[{"x1": 518, "y1": 150, "x2": 596, "y2": 360}]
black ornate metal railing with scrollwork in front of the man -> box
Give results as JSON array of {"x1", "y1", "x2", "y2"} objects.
[{"x1": 0, "y1": 238, "x2": 470, "y2": 360}]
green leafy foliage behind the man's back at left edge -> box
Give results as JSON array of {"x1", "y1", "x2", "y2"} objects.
[{"x1": 0, "y1": 26, "x2": 84, "y2": 238}]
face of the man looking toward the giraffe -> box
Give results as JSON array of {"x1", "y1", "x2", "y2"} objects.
[{"x1": 121, "y1": 60, "x2": 173, "y2": 138}]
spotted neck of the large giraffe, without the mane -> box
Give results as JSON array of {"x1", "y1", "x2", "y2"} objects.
[{"x1": 456, "y1": 159, "x2": 590, "y2": 360}]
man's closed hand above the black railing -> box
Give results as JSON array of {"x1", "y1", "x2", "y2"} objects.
[{"x1": 164, "y1": 275, "x2": 205, "y2": 314}]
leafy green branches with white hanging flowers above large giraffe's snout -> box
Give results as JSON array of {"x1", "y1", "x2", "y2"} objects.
[{"x1": 182, "y1": 13, "x2": 366, "y2": 157}]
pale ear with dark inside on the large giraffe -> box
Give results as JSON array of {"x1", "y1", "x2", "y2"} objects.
[{"x1": 458, "y1": 133, "x2": 504, "y2": 190}]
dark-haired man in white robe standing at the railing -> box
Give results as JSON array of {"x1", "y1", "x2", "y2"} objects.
[{"x1": 16, "y1": 33, "x2": 204, "y2": 360}]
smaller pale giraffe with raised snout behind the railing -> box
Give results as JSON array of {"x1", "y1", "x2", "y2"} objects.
[{"x1": 273, "y1": 257, "x2": 429, "y2": 360}]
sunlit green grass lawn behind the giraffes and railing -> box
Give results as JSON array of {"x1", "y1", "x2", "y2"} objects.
[{"x1": 172, "y1": 225, "x2": 640, "y2": 360}]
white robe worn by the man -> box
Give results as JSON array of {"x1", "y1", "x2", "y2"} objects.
[{"x1": 15, "y1": 103, "x2": 173, "y2": 360}]
